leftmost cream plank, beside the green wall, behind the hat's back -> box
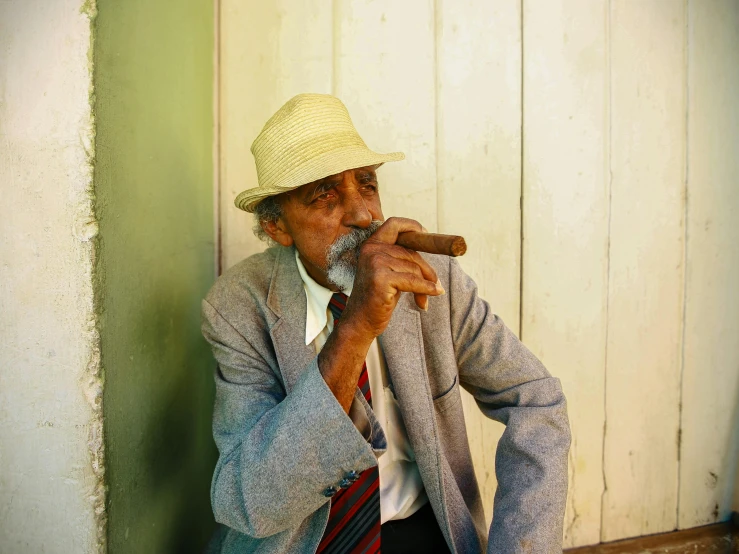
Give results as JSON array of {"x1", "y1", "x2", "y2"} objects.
[{"x1": 219, "y1": 0, "x2": 333, "y2": 270}]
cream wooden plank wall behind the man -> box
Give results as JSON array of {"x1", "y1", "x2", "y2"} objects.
[{"x1": 218, "y1": 0, "x2": 739, "y2": 546}]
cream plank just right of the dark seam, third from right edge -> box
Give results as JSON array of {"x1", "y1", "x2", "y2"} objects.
[{"x1": 522, "y1": 0, "x2": 608, "y2": 546}]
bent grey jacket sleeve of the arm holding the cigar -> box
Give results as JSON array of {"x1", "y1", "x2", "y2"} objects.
[{"x1": 202, "y1": 301, "x2": 377, "y2": 538}]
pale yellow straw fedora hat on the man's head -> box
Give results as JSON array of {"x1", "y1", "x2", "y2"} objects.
[{"x1": 234, "y1": 94, "x2": 405, "y2": 212}]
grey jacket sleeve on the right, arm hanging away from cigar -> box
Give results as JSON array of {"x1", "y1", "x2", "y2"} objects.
[{"x1": 449, "y1": 260, "x2": 570, "y2": 553}]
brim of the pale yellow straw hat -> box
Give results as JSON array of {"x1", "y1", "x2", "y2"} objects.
[{"x1": 234, "y1": 147, "x2": 405, "y2": 213}]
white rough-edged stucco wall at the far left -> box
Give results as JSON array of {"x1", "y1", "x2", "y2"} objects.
[{"x1": 0, "y1": 0, "x2": 105, "y2": 554}]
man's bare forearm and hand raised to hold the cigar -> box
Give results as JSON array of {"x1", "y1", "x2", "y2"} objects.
[{"x1": 318, "y1": 217, "x2": 444, "y2": 413}]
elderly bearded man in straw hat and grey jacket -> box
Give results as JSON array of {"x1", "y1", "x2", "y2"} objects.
[{"x1": 203, "y1": 94, "x2": 570, "y2": 554}]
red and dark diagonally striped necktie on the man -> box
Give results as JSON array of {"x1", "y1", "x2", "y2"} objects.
[{"x1": 317, "y1": 292, "x2": 381, "y2": 554}]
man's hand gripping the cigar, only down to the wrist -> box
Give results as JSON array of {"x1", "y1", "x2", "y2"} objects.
[{"x1": 341, "y1": 217, "x2": 444, "y2": 339}]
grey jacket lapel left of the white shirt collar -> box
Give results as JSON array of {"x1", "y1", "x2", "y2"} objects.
[{"x1": 267, "y1": 247, "x2": 316, "y2": 392}]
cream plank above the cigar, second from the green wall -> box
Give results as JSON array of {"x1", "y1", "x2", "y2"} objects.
[{"x1": 334, "y1": 0, "x2": 437, "y2": 231}]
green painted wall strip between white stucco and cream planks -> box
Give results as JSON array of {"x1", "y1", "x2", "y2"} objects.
[{"x1": 94, "y1": 0, "x2": 215, "y2": 554}]
